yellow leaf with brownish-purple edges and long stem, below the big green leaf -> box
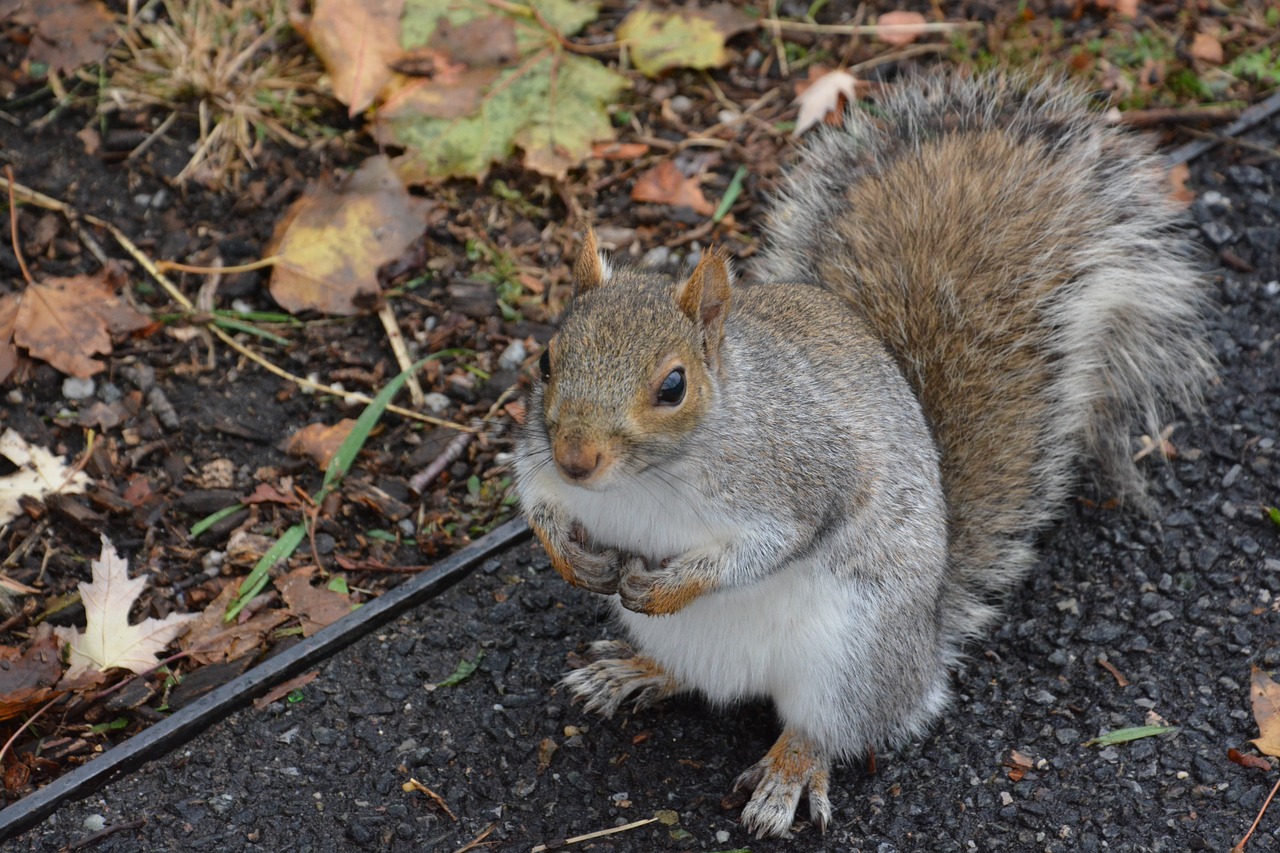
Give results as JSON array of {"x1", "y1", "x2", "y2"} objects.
[{"x1": 269, "y1": 155, "x2": 431, "y2": 315}]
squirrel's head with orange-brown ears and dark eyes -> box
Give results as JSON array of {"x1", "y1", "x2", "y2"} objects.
[{"x1": 535, "y1": 233, "x2": 730, "y2": 488}]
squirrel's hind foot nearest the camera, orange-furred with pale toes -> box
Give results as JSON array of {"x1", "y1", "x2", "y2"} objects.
[{"x1": 733, "y1": 729, "x2": 831, "y2": 838}]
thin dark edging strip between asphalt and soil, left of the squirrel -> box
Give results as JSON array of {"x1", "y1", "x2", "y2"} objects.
[{"x1": 0, "y1": 519, "x2": 529, "y2": 841}]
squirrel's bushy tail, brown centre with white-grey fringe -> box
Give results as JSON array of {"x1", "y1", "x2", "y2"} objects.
[{"x1": 760, "y1": 74, "x2": 1212, "y2": 635}]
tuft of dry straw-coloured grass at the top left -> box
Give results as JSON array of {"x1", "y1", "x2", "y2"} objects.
[{"x1": 99, "y1": 0, "x2": 329, "y2": 190}]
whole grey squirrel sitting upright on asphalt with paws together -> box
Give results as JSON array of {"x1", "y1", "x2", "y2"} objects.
[{"x1": 515, "y1": 73, "x2": 1213, "y2": 836}]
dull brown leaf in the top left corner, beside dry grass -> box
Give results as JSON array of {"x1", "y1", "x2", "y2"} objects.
[{"x1": 9, "y1": 0, "x2": 116, "y2": 73}]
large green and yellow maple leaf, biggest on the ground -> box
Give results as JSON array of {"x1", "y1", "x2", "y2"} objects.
[{"x1": 375, "y1": 0, "x2": 628, "y2": 183}]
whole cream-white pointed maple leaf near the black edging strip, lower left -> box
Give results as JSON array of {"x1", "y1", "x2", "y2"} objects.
[{"x1": 54, "y1": 535, "x2": 195, "y2": 679}]
